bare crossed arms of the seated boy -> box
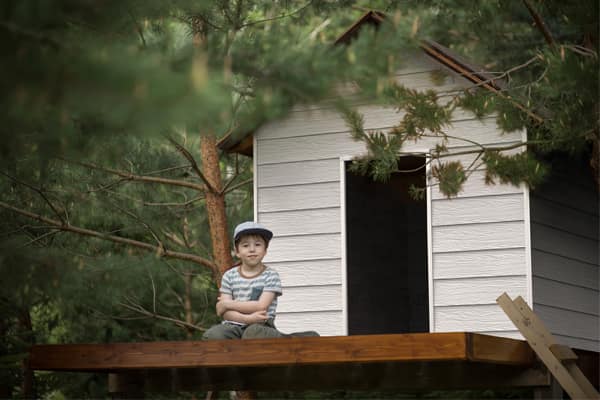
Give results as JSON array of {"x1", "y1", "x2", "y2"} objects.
[{"x1": 216, "y1": 291, "x2": 276, "y2": 324}]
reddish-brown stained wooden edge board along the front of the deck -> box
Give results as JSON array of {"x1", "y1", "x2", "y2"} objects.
[{"x1": 30, "y1": 332, "x2": 531, "y2": 371}]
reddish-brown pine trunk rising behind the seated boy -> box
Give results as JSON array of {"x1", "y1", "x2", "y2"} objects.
[{"x1": 200, "y1": 134, "x2": 233, "y2": 285}]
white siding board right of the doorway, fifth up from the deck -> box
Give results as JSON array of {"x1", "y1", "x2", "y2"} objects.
[{"x1": 431, "y1": 193, "x2": 525, "y2": 226}]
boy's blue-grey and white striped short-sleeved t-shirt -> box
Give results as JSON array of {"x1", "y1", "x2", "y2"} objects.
[{"x1": 220, "y1": 266, "x2": 282, "y2": 324}]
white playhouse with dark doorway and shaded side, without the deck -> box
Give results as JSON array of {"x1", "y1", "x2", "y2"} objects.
[{"x1": 220, "y1": 12, "x2": 600, "y2": 351}]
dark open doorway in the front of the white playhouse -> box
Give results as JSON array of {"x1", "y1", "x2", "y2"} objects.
[{"x1": 346, "y1": 157, "x2": 429, "y2": 335}]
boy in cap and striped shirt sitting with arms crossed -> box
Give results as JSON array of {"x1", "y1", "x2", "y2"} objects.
[{"x1": 203, "y1": 221, "x2": 284, "y2": 340}]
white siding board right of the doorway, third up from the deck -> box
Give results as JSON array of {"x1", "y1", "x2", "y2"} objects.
[{"x1": 433, "y1": 247, "x2": 526, "y2": 279}]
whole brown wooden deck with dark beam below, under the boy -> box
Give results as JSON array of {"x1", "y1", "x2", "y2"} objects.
[{"x1": 29, "y1": 332, "x2": 550, "y2": 392}]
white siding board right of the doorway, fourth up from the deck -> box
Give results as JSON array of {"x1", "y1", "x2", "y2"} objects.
[{"x1": 432, "y1": 221, "x2": 525, "y2": 253}]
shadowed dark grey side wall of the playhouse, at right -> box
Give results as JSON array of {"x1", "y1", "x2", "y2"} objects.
[{"x1": 530, "y1": 169, "x2": 600, "y2": 351}]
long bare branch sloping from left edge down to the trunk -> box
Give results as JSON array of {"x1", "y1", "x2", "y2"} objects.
[{"x1": 0, "y1": 201, "x2": 217, "y2": 272}]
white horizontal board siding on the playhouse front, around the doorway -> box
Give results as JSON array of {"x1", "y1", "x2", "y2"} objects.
[{"x1": 254, "y1": 51, "x2": 529, "y2": 337}]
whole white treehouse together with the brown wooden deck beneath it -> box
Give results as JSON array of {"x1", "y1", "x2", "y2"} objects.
[{"x1": 29, "y1": 12, "x2": 599, "y2": 396}]
